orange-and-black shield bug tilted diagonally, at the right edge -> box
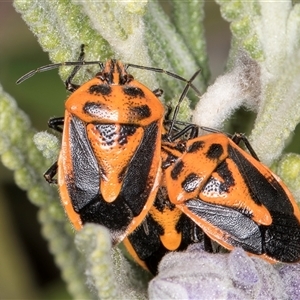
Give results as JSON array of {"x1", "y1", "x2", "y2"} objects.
[{"x1": 162, "y1": 127, "x2": 300, "y2": 262}]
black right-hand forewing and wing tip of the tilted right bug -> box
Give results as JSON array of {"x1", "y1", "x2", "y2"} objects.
[{"x1": 229, "y1": 146, "x2": 300, "y2": 262}]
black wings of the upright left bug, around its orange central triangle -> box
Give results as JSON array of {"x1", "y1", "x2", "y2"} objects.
[{"x1": 66, "y1": 116, "x2": 162, "y2": 244}]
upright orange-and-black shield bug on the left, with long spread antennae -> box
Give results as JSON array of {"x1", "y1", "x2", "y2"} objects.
[{"x1": 17, "y1": 45, "x2": 202, "y2": 244}]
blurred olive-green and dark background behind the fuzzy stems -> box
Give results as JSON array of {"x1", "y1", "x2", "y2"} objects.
[{"x1": 0, "y1": 1, "x2": 300, "y2": 299}]
